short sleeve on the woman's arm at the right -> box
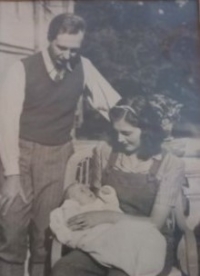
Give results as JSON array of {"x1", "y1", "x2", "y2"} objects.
[{"x1": 156, "y1": 154, "x2": 185, "y2": 207}]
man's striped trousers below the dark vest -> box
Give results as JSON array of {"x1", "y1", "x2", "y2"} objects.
[{"x1": 0, "y1": 140, "x2": 73, "y2": 276}]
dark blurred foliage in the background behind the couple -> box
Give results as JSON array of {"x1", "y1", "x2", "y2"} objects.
[{"x1": 76, "y1": 0, "x2": 200, "y2": 138}]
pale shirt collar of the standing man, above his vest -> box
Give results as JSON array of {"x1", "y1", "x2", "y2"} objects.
[{"x1": 42, "y1": 49, "x2": 72, "y2": 81}]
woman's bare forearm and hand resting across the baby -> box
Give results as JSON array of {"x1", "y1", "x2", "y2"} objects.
[{"x1": 67, "y1": 211, "x2": 124, "y2": 231}]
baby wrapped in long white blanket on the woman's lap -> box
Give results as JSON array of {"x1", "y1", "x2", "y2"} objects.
[{"x1": 50, "y1": 183, "x2": 166, "y2": 276}]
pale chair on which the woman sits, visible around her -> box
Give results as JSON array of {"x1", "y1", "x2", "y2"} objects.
[{"x1": 51, "y1": 146, "x2": 198, "y2": 276}]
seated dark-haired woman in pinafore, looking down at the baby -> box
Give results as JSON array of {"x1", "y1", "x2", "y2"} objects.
[{"x1": 52, "y1": 96, "x2": 184, "y2": 276}]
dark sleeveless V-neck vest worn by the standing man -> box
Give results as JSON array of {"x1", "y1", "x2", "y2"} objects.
[{"x1": 20, "y1": 53, "x2": 84, "y2": 146}]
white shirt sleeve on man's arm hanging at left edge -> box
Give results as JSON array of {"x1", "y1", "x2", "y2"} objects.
[{"x1": 0, "y1": 61, "x2": 25, "y2": 176}]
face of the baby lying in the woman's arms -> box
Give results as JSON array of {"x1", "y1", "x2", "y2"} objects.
[{"x1": 69, "y1": 184, "x2": 96, "y2": 205}]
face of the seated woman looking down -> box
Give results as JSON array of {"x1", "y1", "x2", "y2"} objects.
[{"x1": 113, "y1": 119, "x2": 141, "y2": 153}]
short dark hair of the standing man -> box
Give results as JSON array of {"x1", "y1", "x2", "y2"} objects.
[{"x1": 48, "y1": 13, "x2": 86, "y2": 42}]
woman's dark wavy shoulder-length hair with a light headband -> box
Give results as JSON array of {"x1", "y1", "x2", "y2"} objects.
[{"x1": 109, "y1": 95, "x2": 168, "y2": 160}]
